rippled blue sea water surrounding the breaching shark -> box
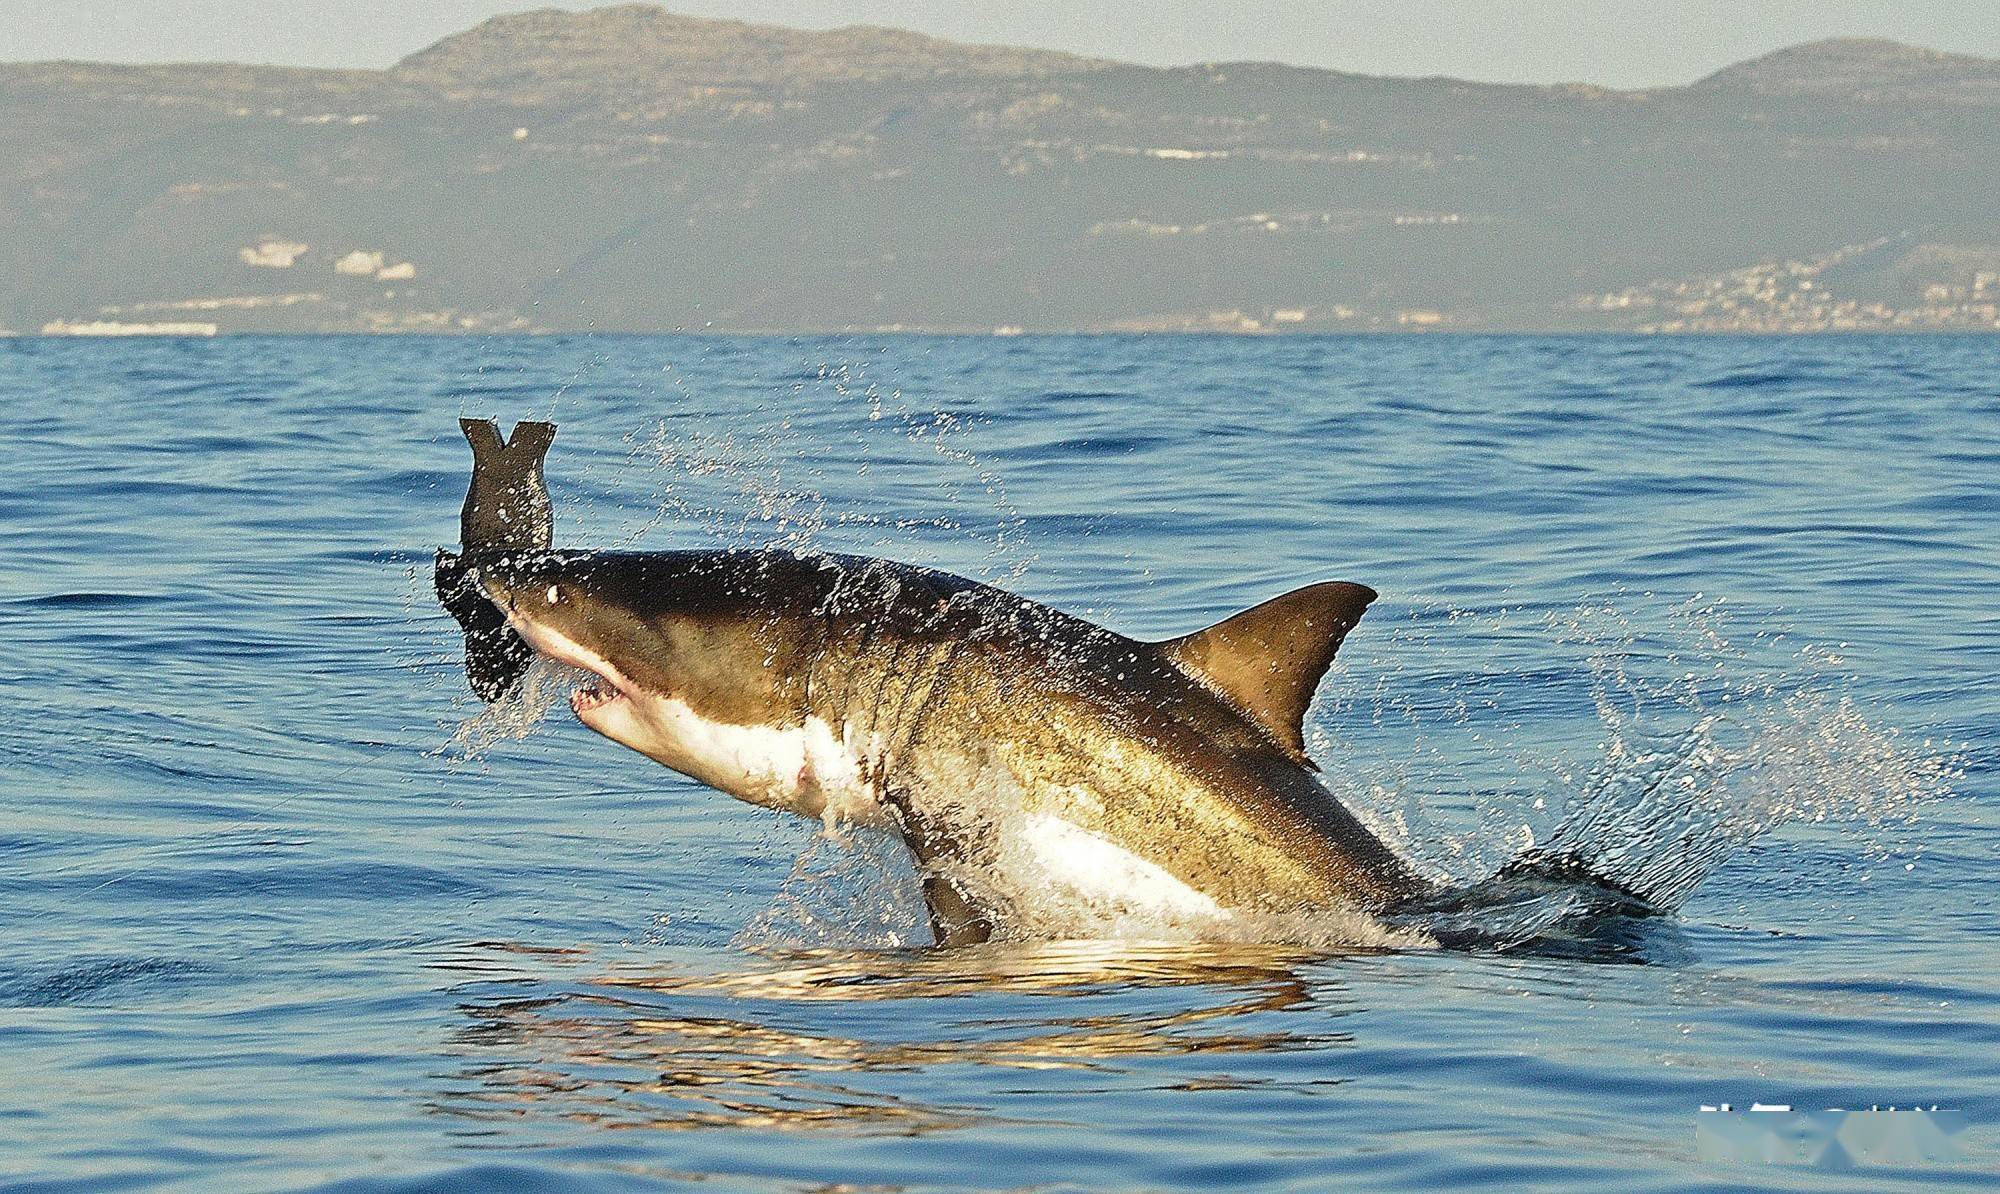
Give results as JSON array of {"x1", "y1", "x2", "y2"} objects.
[{"x1": 0, "y1": 336, "x2": 2000, "y2": 1190}]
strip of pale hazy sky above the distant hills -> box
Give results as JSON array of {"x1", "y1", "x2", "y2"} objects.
[{"x1": 0, "y1": 0, "x2": 2000, "y2": 86}]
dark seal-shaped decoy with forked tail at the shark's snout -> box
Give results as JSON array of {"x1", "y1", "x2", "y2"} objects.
[{"x1": 432, "y1": 418, "x2": 556, "y2": 702}]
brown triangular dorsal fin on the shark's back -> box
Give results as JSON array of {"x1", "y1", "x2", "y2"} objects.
[{"x1": 1158, "y1": 580, "x2": 1376, "y2": 762}]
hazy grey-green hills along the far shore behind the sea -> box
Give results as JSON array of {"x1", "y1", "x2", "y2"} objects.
[{"x1": 0, "y1": 6, "x2": 2000, "y2": 332}]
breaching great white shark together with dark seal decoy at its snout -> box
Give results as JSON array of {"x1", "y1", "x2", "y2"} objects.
[{"x1": 436, "y1": 420, "x2": 1632, "y2": 944}]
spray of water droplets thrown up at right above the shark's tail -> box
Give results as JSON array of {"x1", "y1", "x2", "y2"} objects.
[{"x1": 1316, "y1": 594, "x2": 1962, "y2": 942}]
